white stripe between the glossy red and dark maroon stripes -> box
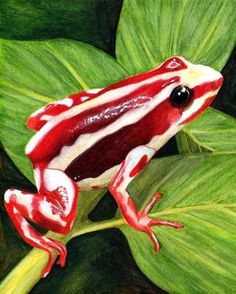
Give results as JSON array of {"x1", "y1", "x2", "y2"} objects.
[{"x1": 48, "y1": 84, "x2": 176, "y2": 170}]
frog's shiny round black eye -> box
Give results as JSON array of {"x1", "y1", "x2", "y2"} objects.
[{"x1": 170, "y1": 86, "x2": 193, "y2": 107}]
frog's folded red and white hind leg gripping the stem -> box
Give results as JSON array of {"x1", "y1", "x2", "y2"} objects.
[{"x1": 4, "y1": 167, "x2": 78, "y2": 277}]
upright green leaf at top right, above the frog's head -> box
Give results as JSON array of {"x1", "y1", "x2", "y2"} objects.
[{"x1": 116, "y1": 0, "x2": 236, "y2": 74}]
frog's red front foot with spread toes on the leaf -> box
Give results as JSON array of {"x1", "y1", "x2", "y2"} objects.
[{"x1": 138, "y1": 193, "x2": 184, "y2": 252}]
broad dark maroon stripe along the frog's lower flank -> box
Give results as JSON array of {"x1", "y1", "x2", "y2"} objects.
[{"x1": 65, "y1": 100, "x2": 181, "y2": 181}]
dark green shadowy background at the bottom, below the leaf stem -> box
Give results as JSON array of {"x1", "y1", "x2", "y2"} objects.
[{"x1": 31, "y1": 230, "x2": 164, "y2": 294}]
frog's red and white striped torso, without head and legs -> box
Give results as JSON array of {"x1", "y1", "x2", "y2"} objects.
[{"x1": 26, "y1": 56, "x2": 188, "y2": 186}]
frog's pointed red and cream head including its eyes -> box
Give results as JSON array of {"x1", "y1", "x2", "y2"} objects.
[{"x1": 157, "y1": 56, "x2": 223, "y2": 126}]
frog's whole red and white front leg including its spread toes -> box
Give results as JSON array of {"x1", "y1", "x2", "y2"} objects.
[{"x1": 109, "y1": 146, "x2": 183, "y2": 252}]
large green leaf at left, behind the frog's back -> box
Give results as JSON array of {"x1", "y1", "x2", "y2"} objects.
[{"x1": 0, "y1": 40, "x2": 126, "y2": 180}]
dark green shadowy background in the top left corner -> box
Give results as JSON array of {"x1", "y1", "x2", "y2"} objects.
[{"x1": 0, "y1": 0, "x2": 122, "y2": 54}]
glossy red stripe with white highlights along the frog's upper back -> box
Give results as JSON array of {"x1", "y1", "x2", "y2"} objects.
[{"x1": 28, "y1": 77, "x2": 179, "y2": 163}]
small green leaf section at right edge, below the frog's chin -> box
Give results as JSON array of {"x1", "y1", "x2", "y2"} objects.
[{"x1": 177, "y1": 108, "x2": 236, "y2": 153}]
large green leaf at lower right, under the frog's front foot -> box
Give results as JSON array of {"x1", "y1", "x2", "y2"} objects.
[{"x1": 121, "y1": 154, "x2": 236, "y2": 293}]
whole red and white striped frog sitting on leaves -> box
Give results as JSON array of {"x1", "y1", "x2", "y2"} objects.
[{"x1": 4, "y1": 57, "x2": 223, "y2": 277}]
